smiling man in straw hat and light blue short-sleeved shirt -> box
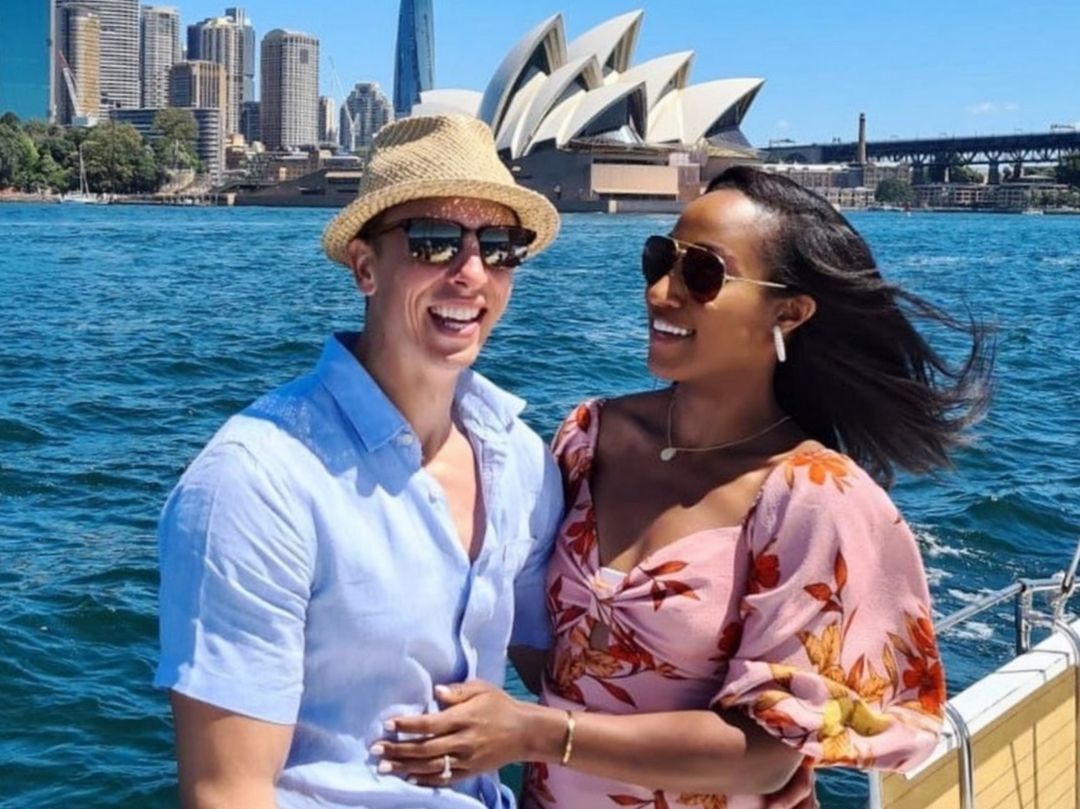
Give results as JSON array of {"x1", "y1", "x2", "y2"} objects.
[{"x1": 156, "y1": 116, "x2": 563, "y2": 809}]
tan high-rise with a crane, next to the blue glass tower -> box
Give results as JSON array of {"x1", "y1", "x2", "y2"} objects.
[{"x1": 55, "y1": 0, "x2": 102, "y2": 124}]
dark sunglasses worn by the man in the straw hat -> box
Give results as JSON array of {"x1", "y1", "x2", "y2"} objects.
[{"x1": 364, "y1": 218, "x2": 537, "y2": 270}]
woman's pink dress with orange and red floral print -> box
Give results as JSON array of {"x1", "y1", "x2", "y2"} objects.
[{"x1": 524, "y1": 402, "x2": 945, "y2": 809}]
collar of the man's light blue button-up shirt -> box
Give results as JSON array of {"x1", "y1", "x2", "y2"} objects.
[{"x1": 315, "y1": 332, "x2": 525, "y2": 451}]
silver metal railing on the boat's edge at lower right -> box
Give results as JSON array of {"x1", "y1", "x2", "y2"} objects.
[{"x1": 911, "y1": 540, "x2": 1080, "y2": 809}]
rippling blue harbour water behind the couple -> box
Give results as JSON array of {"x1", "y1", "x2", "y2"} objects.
[{"x1": 0, "y1": 205, "x2": 1080, "y2": 809}]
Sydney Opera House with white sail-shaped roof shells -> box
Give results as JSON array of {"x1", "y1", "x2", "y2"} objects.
[{"x1": 413, "y1": 11, "x2": 765, "y2": 210}]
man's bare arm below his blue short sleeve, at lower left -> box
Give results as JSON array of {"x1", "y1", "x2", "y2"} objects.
[{"x1": 170, "y1": 691, "x2": 293, "y2": 809}]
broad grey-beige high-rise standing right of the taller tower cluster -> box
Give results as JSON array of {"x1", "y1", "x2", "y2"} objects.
[{"x1": 259, "y1": 28, "x2": 319, "y2": 150}]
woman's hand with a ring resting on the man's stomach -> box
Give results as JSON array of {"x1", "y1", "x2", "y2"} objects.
[{"x1": 372, "y1": 680, "x2": 563, "y2": 786}]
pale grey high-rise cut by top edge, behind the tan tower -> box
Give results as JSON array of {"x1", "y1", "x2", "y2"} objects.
[{"x1": 57, "y1": 0, "x2": 139, "y2": 109}]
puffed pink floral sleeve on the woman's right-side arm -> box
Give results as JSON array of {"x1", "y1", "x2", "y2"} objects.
[{"x1": 714, "y1": 449, "x2": 945, "y2": 770}]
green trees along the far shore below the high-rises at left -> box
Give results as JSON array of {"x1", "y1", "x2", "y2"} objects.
[{"x1": 0, "y1": 108, "x2": 201, "y2": 193}]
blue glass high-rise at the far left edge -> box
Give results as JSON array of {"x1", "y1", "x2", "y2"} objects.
[{"x1": 0, "y1": 0, "x2": 56, "y2": 121}]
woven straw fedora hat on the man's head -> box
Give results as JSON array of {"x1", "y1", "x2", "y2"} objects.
[{"x1": 323, "y1": 114, "x2": 558, "y2": 267}]
